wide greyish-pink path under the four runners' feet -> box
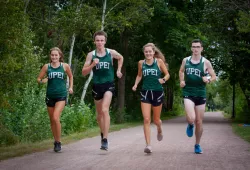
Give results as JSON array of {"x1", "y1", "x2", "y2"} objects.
[{"x1": 0, "y1": 112, "x2": 250, "y2": 170}]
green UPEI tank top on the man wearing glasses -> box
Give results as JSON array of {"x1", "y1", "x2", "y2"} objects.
[{"x1": 183, "y1": 56, "x2": 206, "y2": 98}]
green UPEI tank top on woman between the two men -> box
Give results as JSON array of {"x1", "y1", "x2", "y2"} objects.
[{"x1": 142, "y1": 59, "x2": 163, "y2": 91}]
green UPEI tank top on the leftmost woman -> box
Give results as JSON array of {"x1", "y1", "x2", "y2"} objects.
[{"x1": 46, "y1": 63, "x2": 67, "y2": 98}]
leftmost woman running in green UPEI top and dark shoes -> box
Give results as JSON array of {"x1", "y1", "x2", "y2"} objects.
[{"x1": 37, "y1": 47, "x2": 73, "y2": 152}]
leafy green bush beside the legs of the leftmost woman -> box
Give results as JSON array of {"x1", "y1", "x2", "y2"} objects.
[{"x1": 0, "y1": 84, "x2": 51, "y2": 142}]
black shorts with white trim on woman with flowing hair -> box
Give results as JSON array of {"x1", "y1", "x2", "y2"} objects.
[{"x1": 140, "y1": 90, "x2": 164, "y2": 106}]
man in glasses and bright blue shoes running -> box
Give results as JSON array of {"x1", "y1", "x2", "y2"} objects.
[{"x1": 179, "y1": 39, "x2": 216, "y2": 154}]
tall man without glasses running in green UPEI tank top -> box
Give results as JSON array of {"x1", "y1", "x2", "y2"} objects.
[{"x1": 82, "y1": 31, "x2": 123, "y2": 150}]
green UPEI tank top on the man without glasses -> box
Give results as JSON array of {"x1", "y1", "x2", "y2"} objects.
[{"x1": 92, "y1": 49, "x2": 114, "y2": 84}]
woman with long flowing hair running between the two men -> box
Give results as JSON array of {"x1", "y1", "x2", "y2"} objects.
[{"x1": 132, "y1": 43, "x2": 170, "y2": 153}]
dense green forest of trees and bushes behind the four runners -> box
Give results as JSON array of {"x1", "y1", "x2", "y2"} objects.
[{"x1": 0, "y1": 0, "x2": 250, "y2": 146}]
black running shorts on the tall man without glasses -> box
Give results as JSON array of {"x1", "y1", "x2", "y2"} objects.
[{"x1": 92, "y1": 82, "x2": 115, "y2": 100}]
